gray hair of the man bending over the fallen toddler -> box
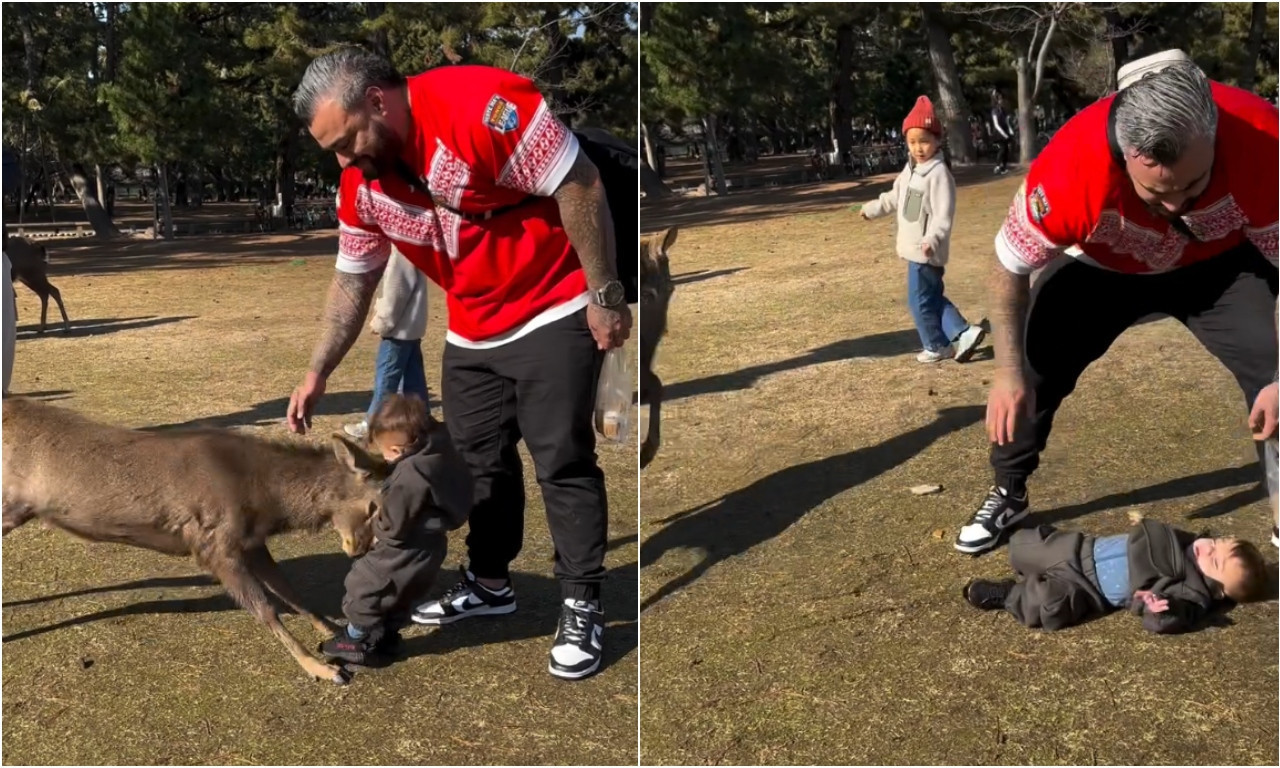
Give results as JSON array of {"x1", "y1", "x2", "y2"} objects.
[{"x1": 1116, "y1": 61, "x2": 1217, "y2": 165}]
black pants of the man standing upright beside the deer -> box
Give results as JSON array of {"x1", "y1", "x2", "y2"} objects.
[{"x1": 442, "y1": 310, "x2": 608, "y2": 600}]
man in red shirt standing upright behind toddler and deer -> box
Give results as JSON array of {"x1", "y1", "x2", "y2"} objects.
[{"x1": 288, "y1": 49, "x2": 631, "y2": 680}]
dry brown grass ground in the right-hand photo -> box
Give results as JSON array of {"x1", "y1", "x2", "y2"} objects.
[{"x1": 640, "y1": 171, "x2": 1277, "y2": 765}]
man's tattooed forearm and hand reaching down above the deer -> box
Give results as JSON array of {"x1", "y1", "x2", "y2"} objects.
[{"x1": 285, "y1": 266, "x2": 385, "y2": 434}]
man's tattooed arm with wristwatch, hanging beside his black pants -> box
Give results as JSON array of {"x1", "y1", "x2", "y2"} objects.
[{"x1": 554, "y1": 150, "x2": 631, "y2": 349}]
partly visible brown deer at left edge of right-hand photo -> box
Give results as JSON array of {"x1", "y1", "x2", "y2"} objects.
[{"x1": 640, "y1": 227, "x2": 678, "y2": 468}]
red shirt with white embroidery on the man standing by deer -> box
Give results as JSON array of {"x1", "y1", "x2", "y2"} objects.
[{"x1": 338, "y1": 67, "x2": 588, "y2": 348}]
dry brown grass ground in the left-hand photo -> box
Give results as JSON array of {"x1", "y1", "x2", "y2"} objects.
[{"x1": 4, "y1": 234, "x2": 636, "y2": 764}]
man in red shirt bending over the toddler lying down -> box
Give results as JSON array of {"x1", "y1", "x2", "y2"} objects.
[{"x1": 955, "y1": 51, "x2": 1280, "y2": 554}]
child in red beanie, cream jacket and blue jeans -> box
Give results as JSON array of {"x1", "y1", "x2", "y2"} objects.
[{"x1": 861, "y1": 96, "x2": 987, "y2": 362}]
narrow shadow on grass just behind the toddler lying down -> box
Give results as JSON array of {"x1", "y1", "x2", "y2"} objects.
[{"x1": 1030, "y1": 463, "x2": 1267, "y2": 525}]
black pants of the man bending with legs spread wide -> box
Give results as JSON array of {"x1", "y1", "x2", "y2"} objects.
[{"x1": 991, "y1": 244, "x2": 1276, "y2": 488}]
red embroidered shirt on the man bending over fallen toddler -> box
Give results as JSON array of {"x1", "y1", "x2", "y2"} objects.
[{"x1": 996, "y1": 82, "x2": 1280, "y2": 274}]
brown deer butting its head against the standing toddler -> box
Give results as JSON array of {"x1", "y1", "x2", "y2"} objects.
[{"x1": 0, "y1": 398, "x2": 387, "y2": 684}]
